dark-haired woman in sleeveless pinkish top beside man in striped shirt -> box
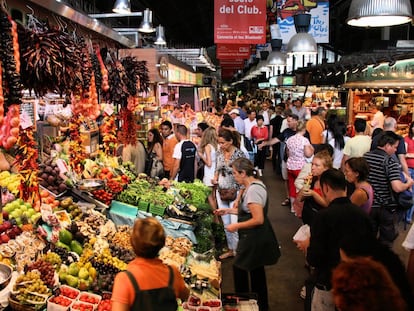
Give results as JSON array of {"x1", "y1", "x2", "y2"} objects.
[{"x1": 344, "y1": 157, "x2": 374, "y2": 215}]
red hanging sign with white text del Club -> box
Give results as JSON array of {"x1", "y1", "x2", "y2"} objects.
[{"x1": 214, "y1": 0, "x2": 266, "y2": 44}]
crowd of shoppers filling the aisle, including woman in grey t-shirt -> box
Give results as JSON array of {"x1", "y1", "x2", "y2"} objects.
[{"x1": 115, "y1": 99, "x2": 414, "y2": 311}]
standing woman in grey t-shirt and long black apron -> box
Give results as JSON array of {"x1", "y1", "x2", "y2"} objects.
[{"x1": 216, "y1": 158, "x2": 280, "y2": 311}]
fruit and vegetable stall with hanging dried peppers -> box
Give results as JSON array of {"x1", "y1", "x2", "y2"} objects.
[{"x1": 0, "y1": 8, "x2": 241, "y2": 311}]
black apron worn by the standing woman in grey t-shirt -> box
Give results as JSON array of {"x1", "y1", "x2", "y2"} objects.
[{"x1": 234, "y1": 183, "x2": 281, "y2": 271}]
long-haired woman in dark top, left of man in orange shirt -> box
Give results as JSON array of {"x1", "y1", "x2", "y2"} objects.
[{"x1": 145, "y1": 128, "x2": 164, "y2": 178}]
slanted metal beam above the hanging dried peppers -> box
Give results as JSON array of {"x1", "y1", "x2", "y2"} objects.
[{"x1": 29, "y1": 0, "x2": 135, "y2": 48}]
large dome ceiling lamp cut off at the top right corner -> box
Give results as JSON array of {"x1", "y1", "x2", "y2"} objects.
[{"x1": 347, "y1": 0, "x2": 412, "y2": 27}]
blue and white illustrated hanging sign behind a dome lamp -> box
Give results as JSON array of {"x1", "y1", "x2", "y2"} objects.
[{"x1": 277, "y1": 0, "x2": 329, "y2": 44}]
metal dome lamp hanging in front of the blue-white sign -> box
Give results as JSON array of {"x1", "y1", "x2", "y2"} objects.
[{"x1": 286, "y1": 14, "x2": 318, "y2": 55}]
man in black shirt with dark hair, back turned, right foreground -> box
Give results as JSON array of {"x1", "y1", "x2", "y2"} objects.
[{"x1": 297, "y1": 169, "x2": 373, "y2": 311}]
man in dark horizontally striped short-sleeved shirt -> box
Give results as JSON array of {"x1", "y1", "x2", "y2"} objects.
[{"x1": 364, "y1": 132, "x2": 413, "y2": 246}]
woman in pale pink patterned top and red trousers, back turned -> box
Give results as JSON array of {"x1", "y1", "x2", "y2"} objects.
[{"x1": 286, "y1": 120, "x2": 313, "y2": 207}]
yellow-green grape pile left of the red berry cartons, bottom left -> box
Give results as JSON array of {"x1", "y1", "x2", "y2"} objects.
[{"x1": 13, "y1": 271, "x2": 51, "y2": 303}]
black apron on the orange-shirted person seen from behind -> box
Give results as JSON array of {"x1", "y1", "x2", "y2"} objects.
[{"x1": 124, "y1": 266, "x2": 178, "y2": 311}]
